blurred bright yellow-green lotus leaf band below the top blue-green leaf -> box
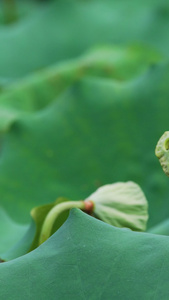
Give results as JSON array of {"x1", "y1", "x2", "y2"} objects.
[{"x1": 0, "y1": 46, "x2": 162, "y2": 131}]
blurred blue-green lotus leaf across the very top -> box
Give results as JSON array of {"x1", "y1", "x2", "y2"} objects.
[{"x1": 0, "y1": 0, "x2": 169, "y2": 83}]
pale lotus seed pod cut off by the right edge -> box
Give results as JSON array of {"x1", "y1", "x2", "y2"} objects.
[{"x1": 155, "y1": 131, "x2": 169, "y2": 176}]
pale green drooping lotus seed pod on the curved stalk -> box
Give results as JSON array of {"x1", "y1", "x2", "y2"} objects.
[{"x1": 85, "y1": 181, "x2": 148, "y2": 231}]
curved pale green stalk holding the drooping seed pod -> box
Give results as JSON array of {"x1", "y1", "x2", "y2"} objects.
[{"x1": 39, "y1": 201, "x2": 85, "y2": 245}]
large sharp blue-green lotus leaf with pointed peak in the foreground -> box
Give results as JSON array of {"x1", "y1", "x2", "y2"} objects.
[{"x1": 0, "y1": 210, "x2": 169, "y2": 300}]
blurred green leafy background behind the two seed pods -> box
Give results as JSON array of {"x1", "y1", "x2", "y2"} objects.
[{"x1": 0, "y1": 0, "x2": 169, "y2": 231}]
